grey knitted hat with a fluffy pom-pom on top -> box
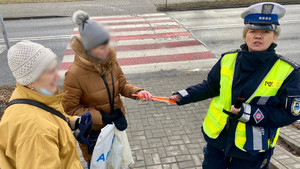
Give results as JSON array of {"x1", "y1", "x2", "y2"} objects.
[{"x1": 73, "y1": 10, "x2": 109, "y2": 50}]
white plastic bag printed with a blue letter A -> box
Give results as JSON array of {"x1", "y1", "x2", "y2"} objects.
[{"x1": 91, "y1": 124, "x2": 115, "y2": 169}]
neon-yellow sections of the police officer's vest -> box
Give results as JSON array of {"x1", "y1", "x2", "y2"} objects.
[{"x1": 203, "y1": 53, "x2": 294, "y2": 151}]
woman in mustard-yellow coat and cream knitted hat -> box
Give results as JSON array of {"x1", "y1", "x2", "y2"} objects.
[{"x1": 0, "y1": 41, "x2": 82, "y2": 169}]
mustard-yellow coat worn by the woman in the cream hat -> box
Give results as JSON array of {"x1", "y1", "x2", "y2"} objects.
[{"x1": 0, "y1": 84, "x2": 82, "y2": 169}]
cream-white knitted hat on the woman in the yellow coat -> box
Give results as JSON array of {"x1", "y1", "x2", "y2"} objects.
[{"x1": 7, "y1": 40, "x2": 57, "y2": 86}]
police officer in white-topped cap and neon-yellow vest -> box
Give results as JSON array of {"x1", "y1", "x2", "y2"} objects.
[{"x1": 170, "y1": 2, "x2": 300, "y2": 169}]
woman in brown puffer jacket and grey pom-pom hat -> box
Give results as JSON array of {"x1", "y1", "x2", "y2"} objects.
[{"x1": 63, "y1": 11, "x2": 152, "y2": 164}]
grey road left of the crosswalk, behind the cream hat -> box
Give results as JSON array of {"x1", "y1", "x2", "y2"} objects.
[{"x1": 0, "y1": 17, "x2": 75, "y2": 86}]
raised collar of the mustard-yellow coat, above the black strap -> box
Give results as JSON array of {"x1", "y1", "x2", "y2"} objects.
[{"x1": 11, "y1": 83, "x2": 63, "y2": 107}]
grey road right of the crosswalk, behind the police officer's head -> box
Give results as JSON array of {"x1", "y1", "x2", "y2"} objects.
[{"x1": 167, "y1": 5, "x2": 300, "y2": 63}]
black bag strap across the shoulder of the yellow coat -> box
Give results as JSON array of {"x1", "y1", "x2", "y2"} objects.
[{"x1": 6, "y1": 99, "x2": 69, "y2": 124}]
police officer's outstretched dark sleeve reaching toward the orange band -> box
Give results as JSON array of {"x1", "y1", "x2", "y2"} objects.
[{"x1": 176, "y1": 59, "x2": 221, "y2": 105}]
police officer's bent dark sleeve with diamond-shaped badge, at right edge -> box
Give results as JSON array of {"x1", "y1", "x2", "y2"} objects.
[{"x1": 238, "y1": 71, "x2": 300, "y2": 127}]
